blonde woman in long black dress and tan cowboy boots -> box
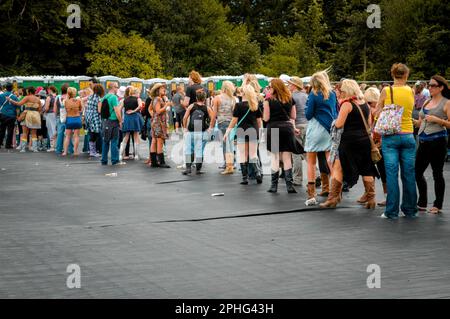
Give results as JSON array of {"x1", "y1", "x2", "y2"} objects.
[{"x1": 320, "y1": 79, "x2": 377, "y2": 209}]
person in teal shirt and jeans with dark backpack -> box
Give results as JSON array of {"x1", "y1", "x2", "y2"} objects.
[{"x1": 101, "y1": 82, "x2": 122, "y2": 165}]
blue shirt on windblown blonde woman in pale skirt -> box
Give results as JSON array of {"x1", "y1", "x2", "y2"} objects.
[{"x1": 305, "y1": 91, "x2": 337, "y2": 132}]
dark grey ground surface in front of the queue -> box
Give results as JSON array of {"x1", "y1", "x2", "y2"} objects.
[{"x1": 0, "y1": 141, "x2": 450, "y2": 298}]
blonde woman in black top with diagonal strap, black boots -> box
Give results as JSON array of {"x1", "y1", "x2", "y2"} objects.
[{"x1": 224, "y1": 85, "x2": 262, "y2": 185}]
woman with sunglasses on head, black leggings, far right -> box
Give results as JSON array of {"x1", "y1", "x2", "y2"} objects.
[{"x1": 415, "y1": 75, "x2": 450, "y2": 214}]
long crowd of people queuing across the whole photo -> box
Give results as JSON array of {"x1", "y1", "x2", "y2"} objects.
[{"x1": 0, "y1": 63, "x2": 450, "y2": 219}]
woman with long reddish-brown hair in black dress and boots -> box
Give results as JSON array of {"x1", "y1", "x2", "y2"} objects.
[{"x1": 264, "y1": 79, "x2": 298, "y2": 193}]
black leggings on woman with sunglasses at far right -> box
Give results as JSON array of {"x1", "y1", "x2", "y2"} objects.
[{"x1": 416, "y1": 137, "x2": 447, "y2": 209}]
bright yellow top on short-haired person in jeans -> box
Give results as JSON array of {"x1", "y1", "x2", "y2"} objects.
[{"x1": 384, "y1": 85, "x2": 414, "y2": 133}]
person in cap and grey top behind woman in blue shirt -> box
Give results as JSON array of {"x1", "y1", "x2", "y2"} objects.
[{"x1": 288, "y1": 76, "x2": 310, "y2": 186}]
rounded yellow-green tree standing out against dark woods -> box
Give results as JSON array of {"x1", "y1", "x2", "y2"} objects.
[{"x1": 86, "y1": 29, "x2": 162, "y2": 79}]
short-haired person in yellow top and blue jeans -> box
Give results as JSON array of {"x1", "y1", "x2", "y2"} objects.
[{"x1": 377, "y1": 63, "x2": 417, "y2": 219}]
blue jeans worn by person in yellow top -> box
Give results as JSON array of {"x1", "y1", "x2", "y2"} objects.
[{"x1": 381, "y1": 134, "x2": 417, "y2": 219}]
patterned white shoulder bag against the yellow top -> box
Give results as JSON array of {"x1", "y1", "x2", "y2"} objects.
[{"x1": 374, "y1": 86, "x2": 403, "y2": 135}]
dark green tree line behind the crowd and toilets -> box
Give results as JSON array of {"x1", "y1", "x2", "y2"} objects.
[{"x1": 0, "y1": 0, "x2": 450, "y2": 80}]
